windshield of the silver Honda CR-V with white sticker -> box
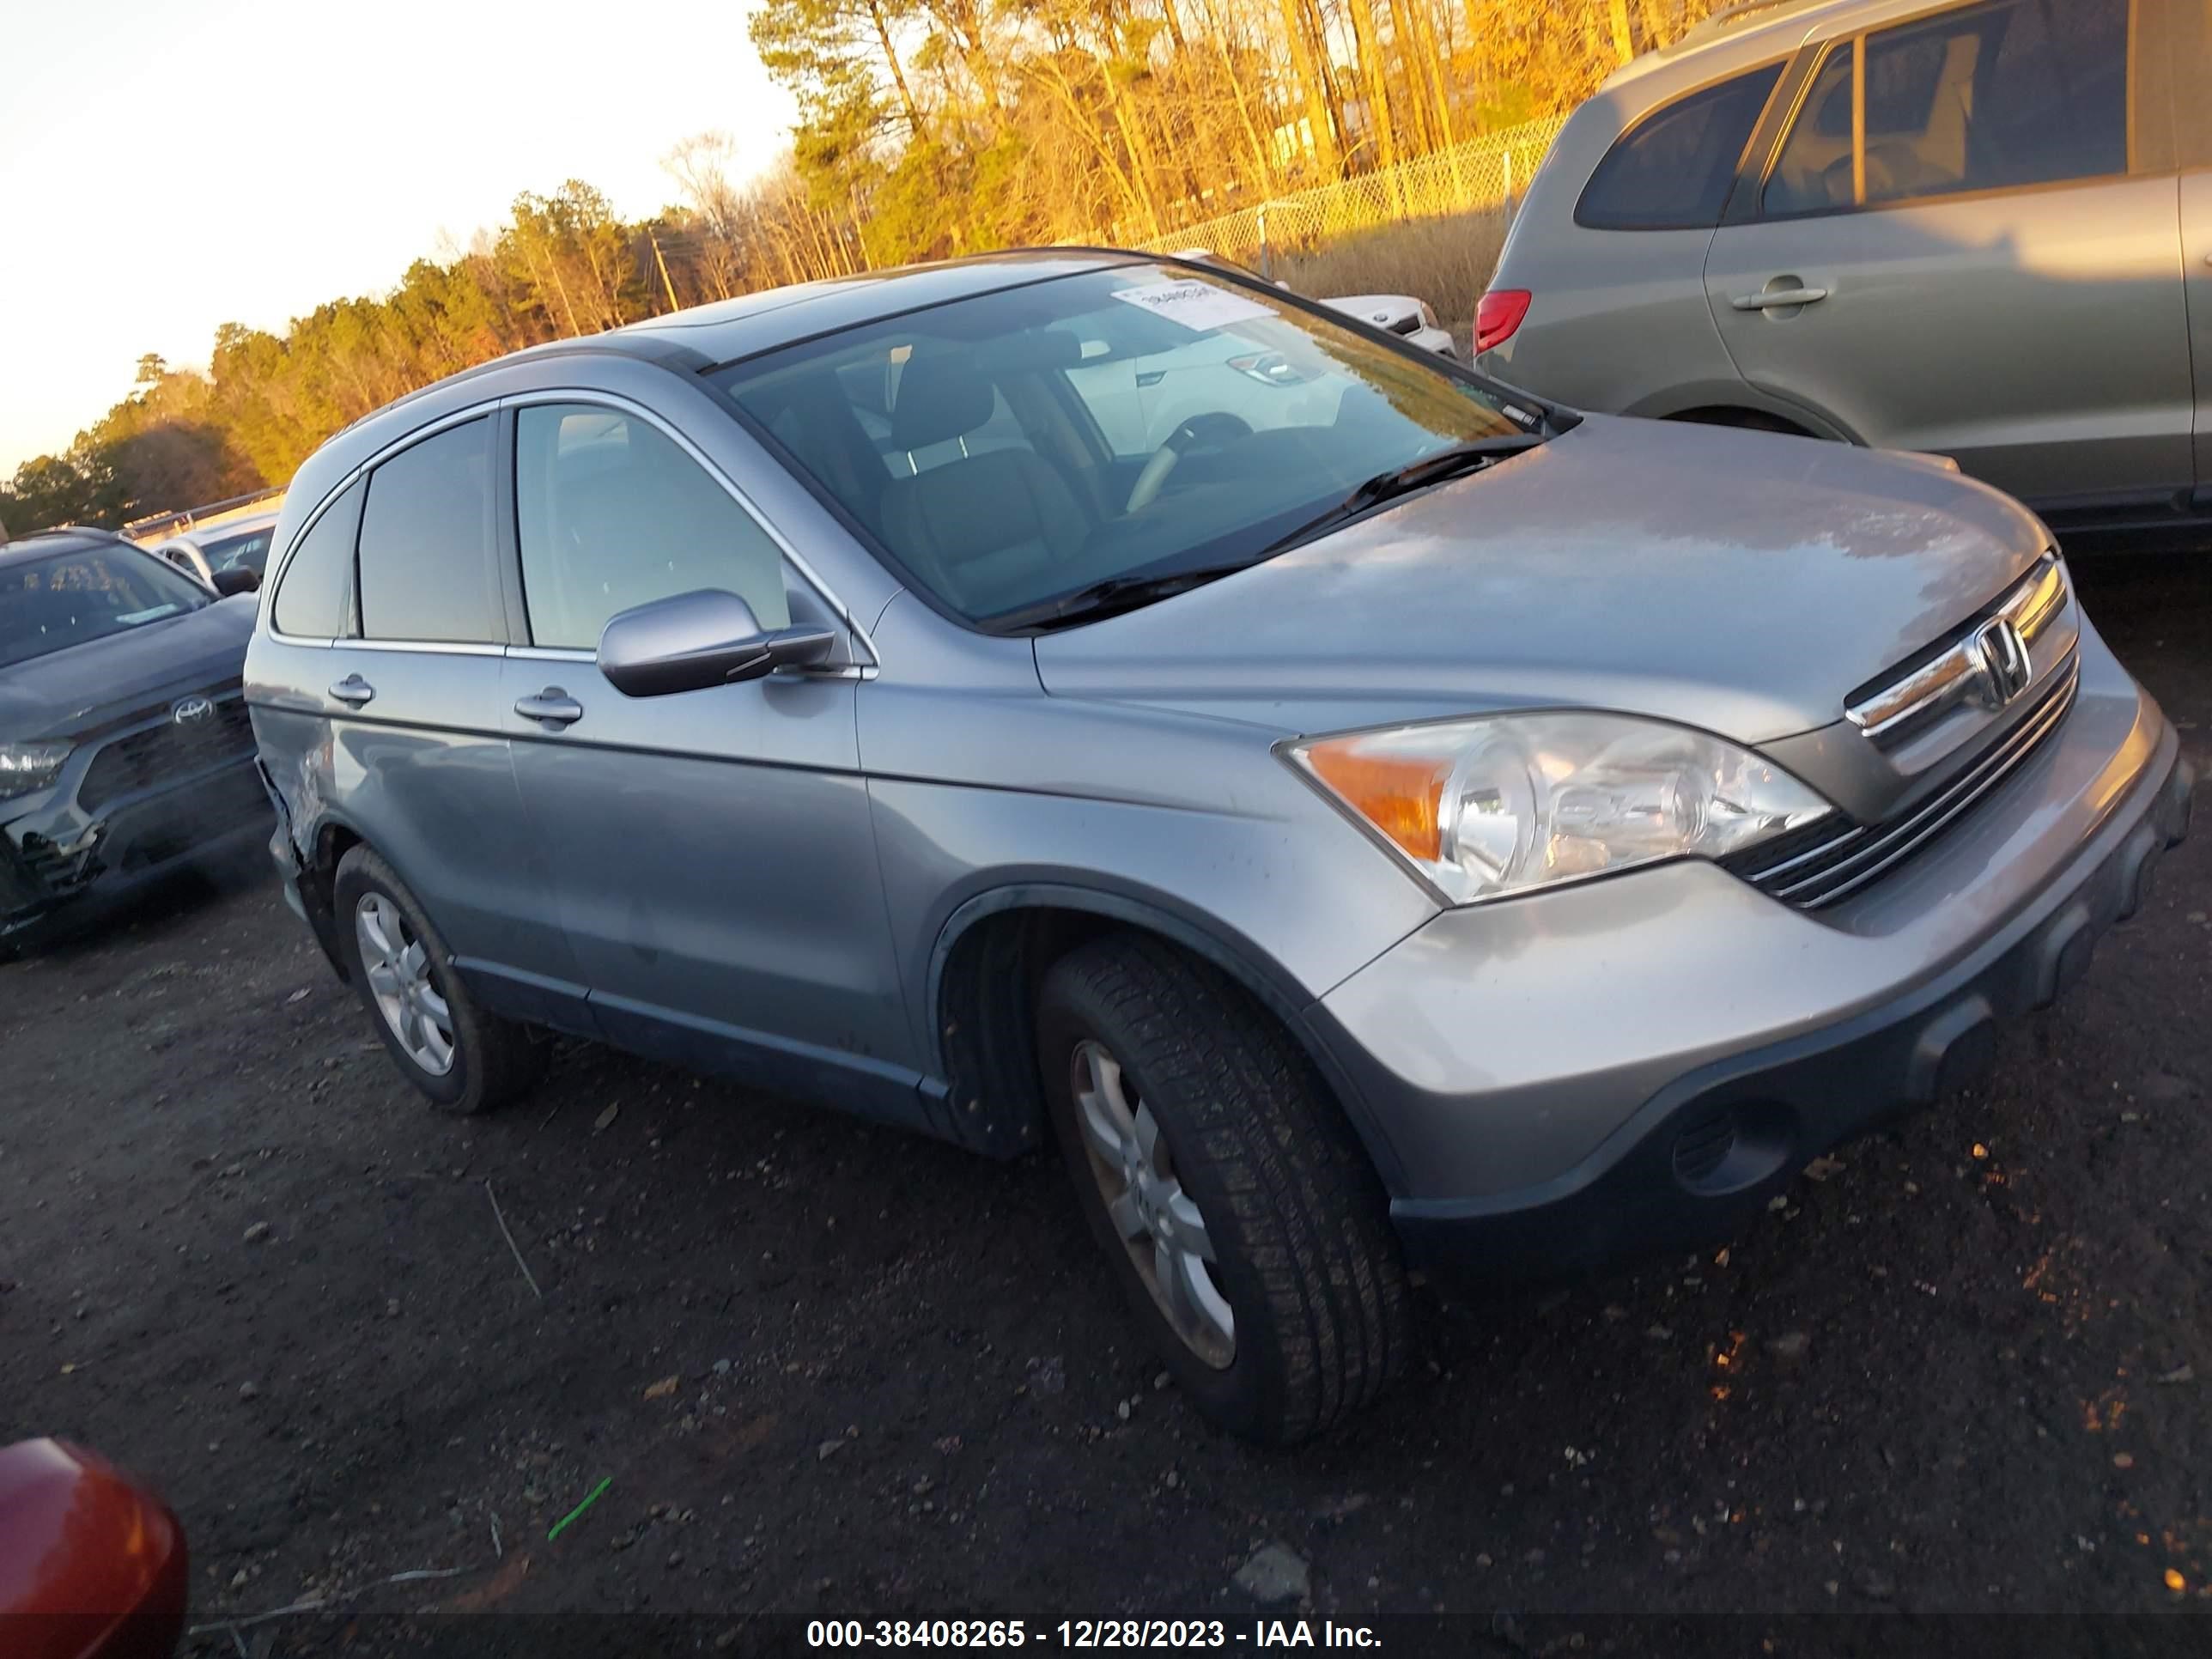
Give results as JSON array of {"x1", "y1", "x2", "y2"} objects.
[{"x1": 710, "y1": 265, "x2": 1540, "y2": 626}]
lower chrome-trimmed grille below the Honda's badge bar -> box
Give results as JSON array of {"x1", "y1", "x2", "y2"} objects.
[{"x1": 1721, "y1": 657, "x2": 2081, "y2": 909}]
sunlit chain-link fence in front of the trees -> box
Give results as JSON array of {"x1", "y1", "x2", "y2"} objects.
[{"x1": 1103, "y1": 115, "x2": 1566, "y2": 265}]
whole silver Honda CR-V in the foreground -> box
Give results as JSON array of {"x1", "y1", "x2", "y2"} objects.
[{"x1": 248, "y1": 250, "x2": 2190, "y2": 1440}]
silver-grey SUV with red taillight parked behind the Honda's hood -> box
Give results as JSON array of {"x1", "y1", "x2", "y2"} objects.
[{"x1": 1475, "y1": 0, "x2": 2212, "y2": 548}]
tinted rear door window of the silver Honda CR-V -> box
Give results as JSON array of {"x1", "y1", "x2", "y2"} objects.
[{"x1": 361, "y1": 418, "x2": 502, "y2": 641}]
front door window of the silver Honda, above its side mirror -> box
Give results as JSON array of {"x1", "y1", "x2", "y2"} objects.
[{"x1": 515, "y1": 403, "x2": 792, "y2": 650}]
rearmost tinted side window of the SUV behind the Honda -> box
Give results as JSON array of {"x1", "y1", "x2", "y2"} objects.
[{"x1": 1575, "y1": 64, "x2": 1783, "y2": 230}]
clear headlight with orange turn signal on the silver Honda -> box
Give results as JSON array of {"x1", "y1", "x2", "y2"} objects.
[{"x1": 1290, "y1": 714, "x2": 1832, "y2": 905}]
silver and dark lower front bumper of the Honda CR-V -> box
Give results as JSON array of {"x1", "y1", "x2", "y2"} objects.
[{"x1": 1310, "y1": 635, "x2": 2194, "y2": 1281}]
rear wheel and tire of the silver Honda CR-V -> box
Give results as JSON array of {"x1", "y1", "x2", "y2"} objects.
[{"x1": 331, "y1": 848, "x2": 544, "y2": 1117}]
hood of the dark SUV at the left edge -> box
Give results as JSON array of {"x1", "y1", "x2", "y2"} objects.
[{"x1": 0, "y1": 592, "x2": 254, "y2": 741}]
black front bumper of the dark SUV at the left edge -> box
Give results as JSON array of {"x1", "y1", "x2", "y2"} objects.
[{"x1": 0, "y1": 754, "x2": 270, "y2": 936}]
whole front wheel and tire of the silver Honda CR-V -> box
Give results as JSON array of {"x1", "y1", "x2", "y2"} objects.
[{"x1": 1037, "y1": 933, "x2": 1413, "y2": 1444}]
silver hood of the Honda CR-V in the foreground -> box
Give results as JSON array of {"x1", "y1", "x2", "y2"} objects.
[{"x1": 1036, "y1": 416, "x2": 2048, "y2": 744}]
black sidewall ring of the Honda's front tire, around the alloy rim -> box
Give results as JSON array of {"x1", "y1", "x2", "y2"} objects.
[{"x1": 1037, "y1": 975, "x2": 1283, "y2": 1437}]
